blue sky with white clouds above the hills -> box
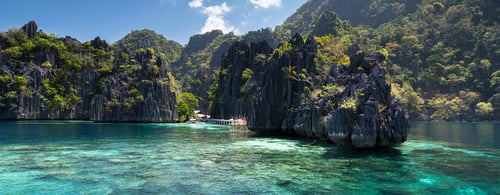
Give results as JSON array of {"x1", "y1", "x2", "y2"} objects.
[{"x1": 0, "y1": 0, "x2": 307, "y2": 44}]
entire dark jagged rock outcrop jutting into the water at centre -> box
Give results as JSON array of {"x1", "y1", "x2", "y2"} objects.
[{"x1": 212, "y1": 35, "x2": 409, "y2": 148}]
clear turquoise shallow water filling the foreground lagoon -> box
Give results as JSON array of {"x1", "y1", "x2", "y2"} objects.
[{"x1": 0, "y1": 121, "x2": 500, "y2": 194}]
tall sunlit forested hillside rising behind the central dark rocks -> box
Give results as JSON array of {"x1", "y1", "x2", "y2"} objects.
[{"x1": 276, "y1": 0, "x2": 500, "y2": 121}]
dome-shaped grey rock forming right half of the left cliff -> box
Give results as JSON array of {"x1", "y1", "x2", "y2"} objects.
[{"x1": 90, "y1": 46, "x2": 177, "y2": 122}]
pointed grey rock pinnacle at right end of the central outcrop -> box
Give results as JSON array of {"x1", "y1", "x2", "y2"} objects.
[{"x1": 326, "y1": 53, "x2": 409, "y2": 148}]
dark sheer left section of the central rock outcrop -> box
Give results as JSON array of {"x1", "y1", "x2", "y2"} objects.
[{"x1": 211, "y1": 35, "x2": 326, "y2": 136}]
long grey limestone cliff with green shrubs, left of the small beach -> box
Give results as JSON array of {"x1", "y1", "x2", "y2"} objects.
[{"x1": 0, "y1": 21, "x2": 181, "y2": 122}]
